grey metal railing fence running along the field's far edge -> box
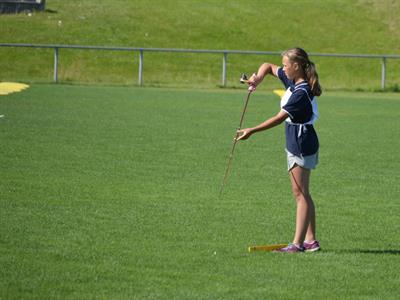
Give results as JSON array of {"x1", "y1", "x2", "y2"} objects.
[{"x1": 0, "y1": 43, "x2": 400, "y2": 89}]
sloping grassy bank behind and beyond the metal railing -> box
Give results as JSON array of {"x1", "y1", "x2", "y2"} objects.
[{"x1": 0, "y1": 0, "x2": 400, "y2": 91}]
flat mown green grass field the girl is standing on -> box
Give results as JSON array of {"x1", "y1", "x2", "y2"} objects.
[{"x1": 0, "y1": 85, "x2": 400, "y2": 299}]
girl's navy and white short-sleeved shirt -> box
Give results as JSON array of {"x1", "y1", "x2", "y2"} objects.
[{"x1": 277, "y1": 68, "x2": 319, "y2": 156}]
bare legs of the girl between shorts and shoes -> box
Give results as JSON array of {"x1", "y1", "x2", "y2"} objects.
[{"x1": 290, "y1": 165, "x2": 315, "y2": 245}]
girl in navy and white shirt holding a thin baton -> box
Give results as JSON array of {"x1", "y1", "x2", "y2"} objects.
[{"x1": 237, "y1": 48, "x2": 322, "y2": 253}]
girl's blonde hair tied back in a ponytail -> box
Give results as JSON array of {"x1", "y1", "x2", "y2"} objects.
[{"x1": 282, "y1": 48, "x2": 322, "y2": 96}]
